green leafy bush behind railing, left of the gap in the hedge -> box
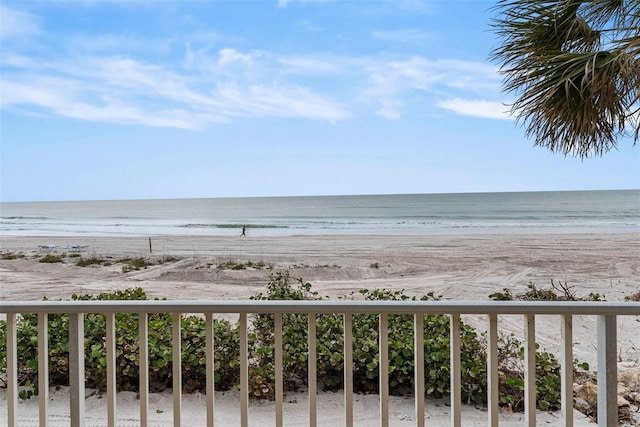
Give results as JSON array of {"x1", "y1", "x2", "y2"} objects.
[{"x1": 0, "y1": 288, "x2": 239, "y2": 397}]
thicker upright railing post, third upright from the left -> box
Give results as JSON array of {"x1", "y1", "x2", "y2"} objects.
[{"x1": 69, "y1": 313, "x2": 85, "y2": 427}]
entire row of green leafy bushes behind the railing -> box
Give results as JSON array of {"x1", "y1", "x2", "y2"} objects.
[{"x1": 0, "y1": 272, "x2": 584, "y2": 411}]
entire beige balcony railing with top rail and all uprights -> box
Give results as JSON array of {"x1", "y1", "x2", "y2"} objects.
[{"x1": 0, "y1": 301, "x2": 640, "y2": 427}]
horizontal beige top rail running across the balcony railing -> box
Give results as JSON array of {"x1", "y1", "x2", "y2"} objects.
[{"x1": 0, "y1": 300, "x2": 640, "y2": 315}]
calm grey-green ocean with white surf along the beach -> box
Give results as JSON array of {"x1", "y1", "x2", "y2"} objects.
[{"x1": 0, "y1": 190, "x2": 640, "y2": 237}]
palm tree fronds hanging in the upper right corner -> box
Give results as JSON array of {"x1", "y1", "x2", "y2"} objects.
[{"x1": 491, "y1": 0, "x2": 640, "y2": 158}]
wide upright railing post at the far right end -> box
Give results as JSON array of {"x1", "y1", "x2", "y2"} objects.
[{"x1": 597, "y1": 315, "x2": 618, "y2": 426}]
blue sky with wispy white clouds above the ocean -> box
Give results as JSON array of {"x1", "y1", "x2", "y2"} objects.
[{"x1": 0, "y1": 0, "x2": 640, "y2": 201}]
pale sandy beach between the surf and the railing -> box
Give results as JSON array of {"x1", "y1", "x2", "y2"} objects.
[{"x1": 0, "y1": 233, "x2": 640, "y2": 425}]
